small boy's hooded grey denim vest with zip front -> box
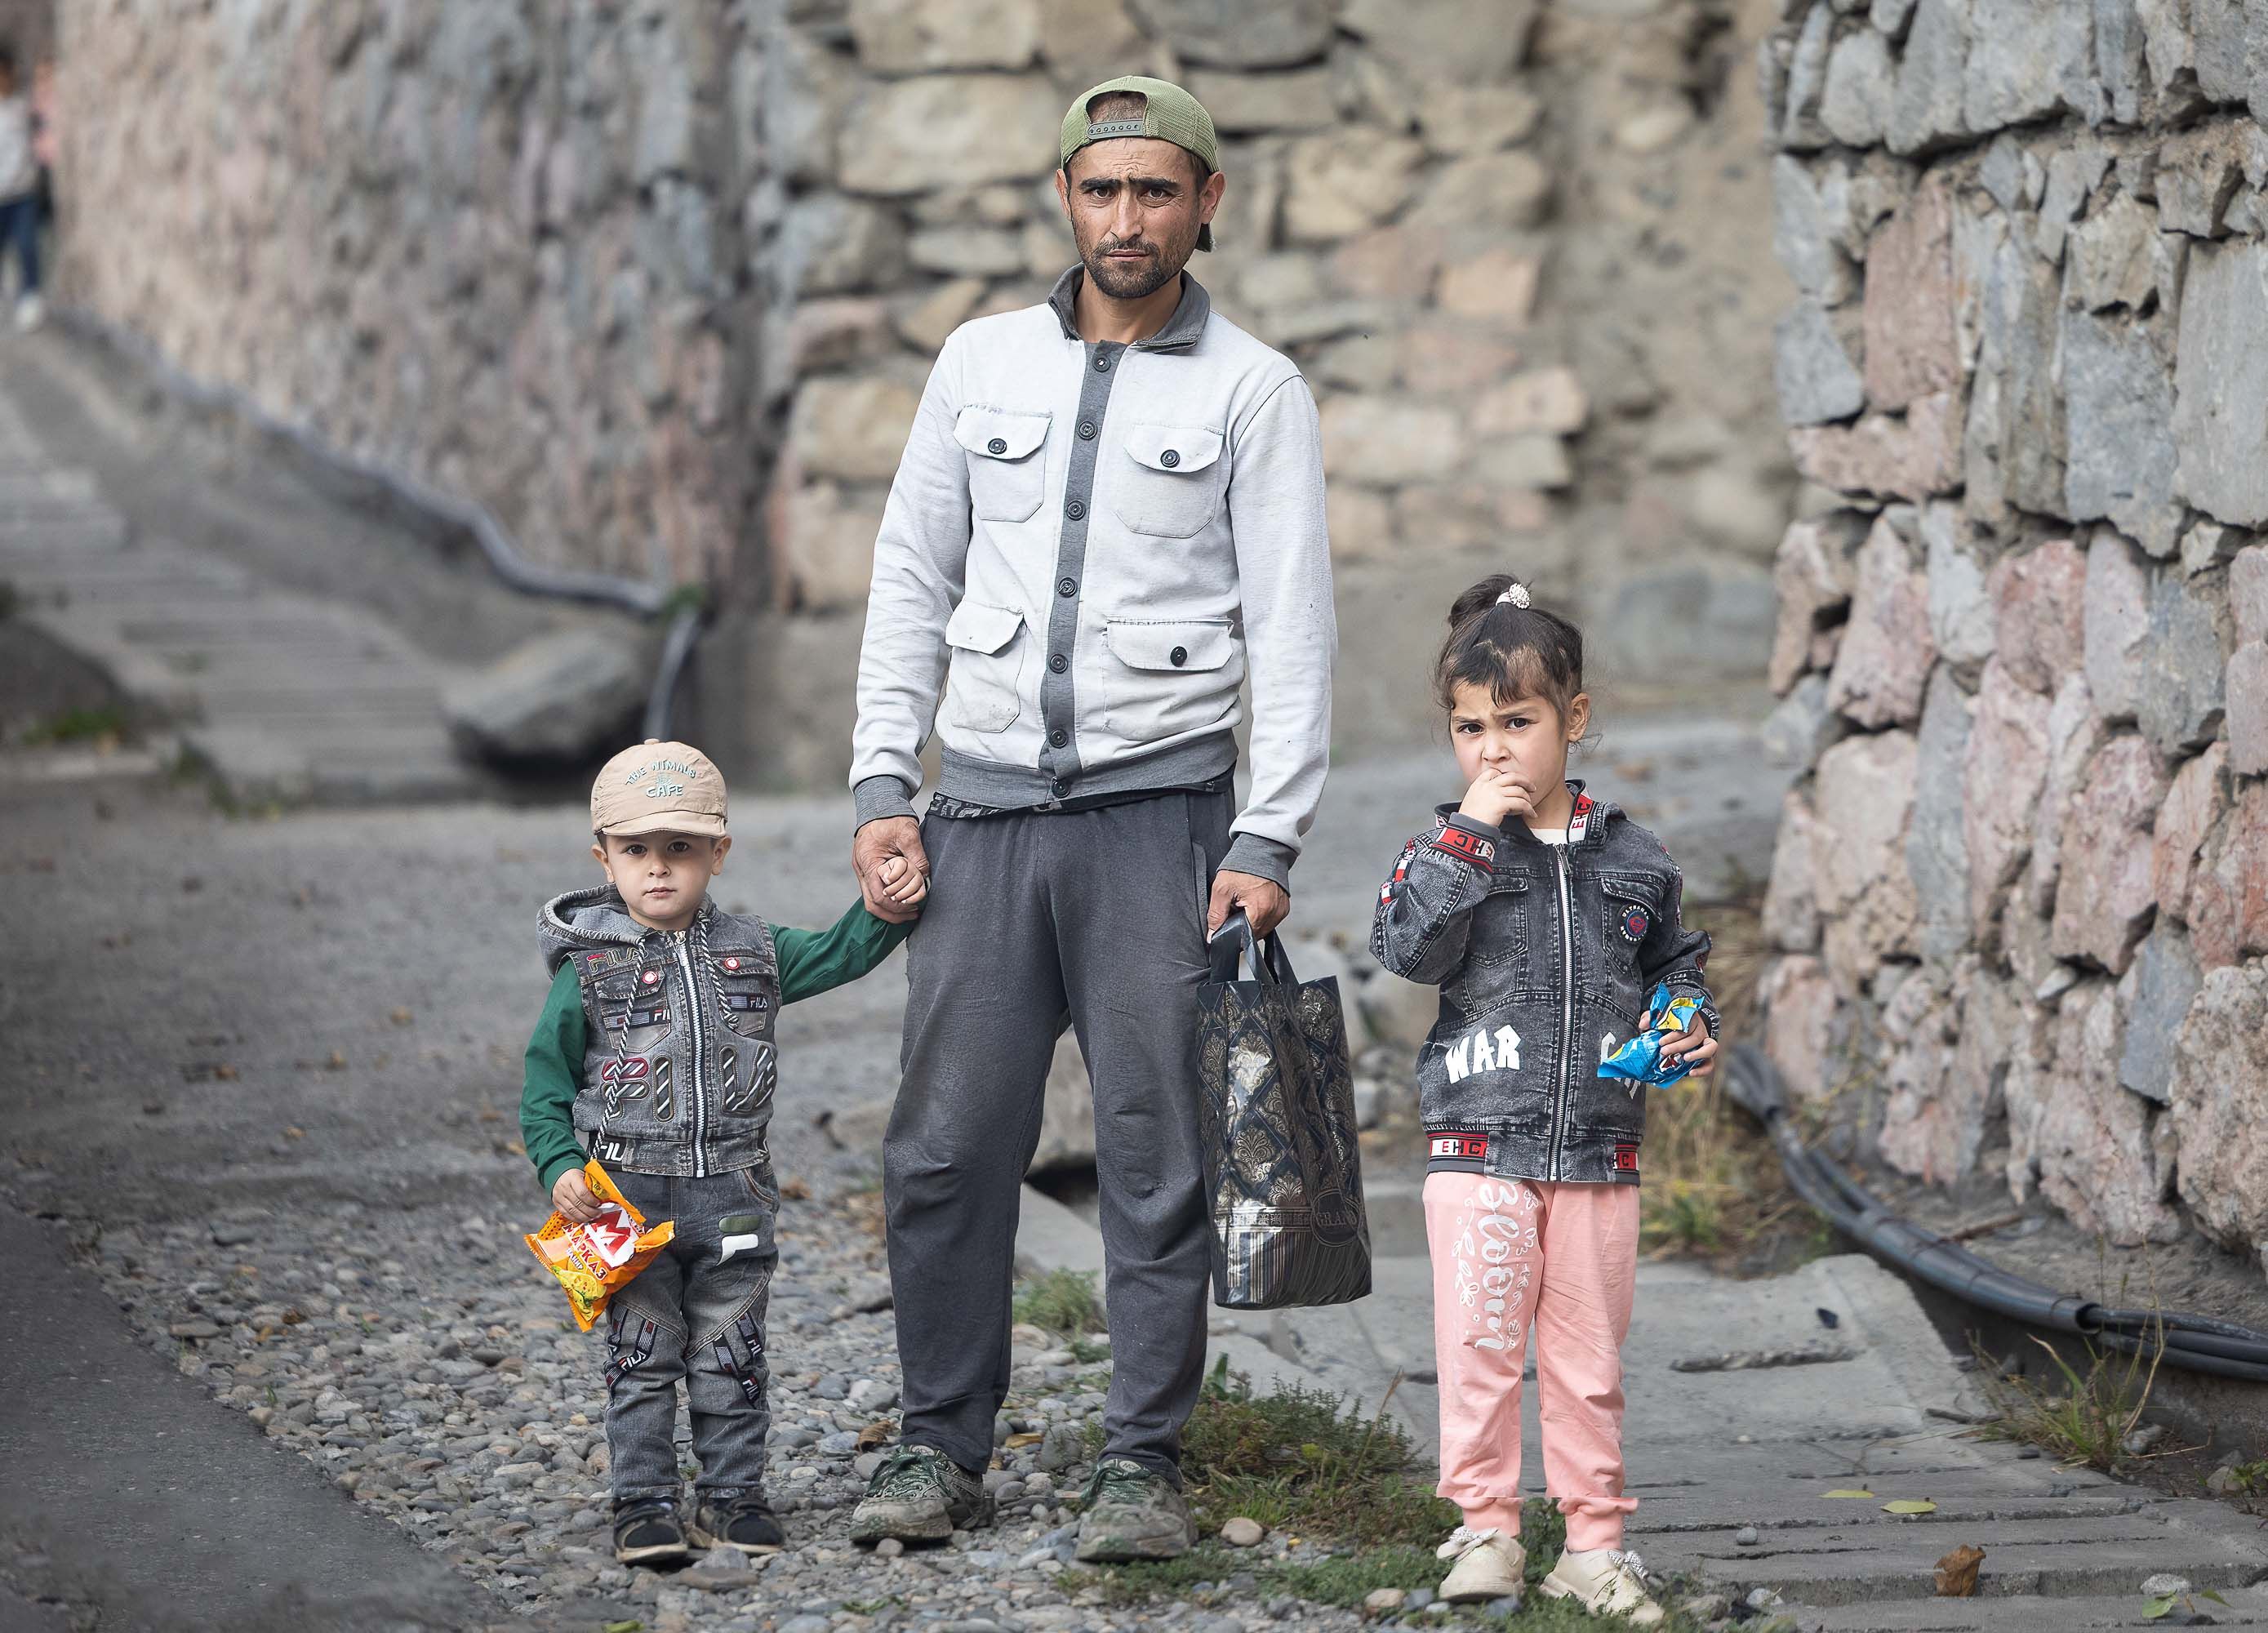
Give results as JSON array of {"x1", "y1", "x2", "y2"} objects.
[{"x1": 542, "y1": 887, "x2": 780, "y2": 1177}]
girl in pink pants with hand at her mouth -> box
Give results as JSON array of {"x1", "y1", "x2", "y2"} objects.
[{"x1": 1370, "y1": 576, "x2": 1717, "y2": 1624}]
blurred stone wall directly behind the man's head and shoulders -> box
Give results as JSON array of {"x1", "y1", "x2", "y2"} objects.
[{"x1": 767, "y1": 0, "x2": 1794, "y2": 693}]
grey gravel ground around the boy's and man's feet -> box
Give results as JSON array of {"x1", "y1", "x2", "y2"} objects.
[{"x1": 70, "y1": 1190, "x2": 1361, "y2": 1633}]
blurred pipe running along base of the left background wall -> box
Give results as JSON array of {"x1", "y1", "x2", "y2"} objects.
[{"x1": 55, "y1": 306, "x2": 700, "y2": 737}]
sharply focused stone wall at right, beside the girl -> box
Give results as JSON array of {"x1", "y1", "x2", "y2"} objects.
[{"x1": 1760, "y1": 0, "x2": 2268, "y2": 1261}]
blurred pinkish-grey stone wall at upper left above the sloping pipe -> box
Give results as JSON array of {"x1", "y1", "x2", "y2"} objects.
[{"x1": 59, "y1": 0, "x2": 773, "y2": 578}]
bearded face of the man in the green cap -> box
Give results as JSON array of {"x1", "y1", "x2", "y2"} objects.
[{"x1": 1055, "y1": 136, "x2": 1227, "y2": 300}]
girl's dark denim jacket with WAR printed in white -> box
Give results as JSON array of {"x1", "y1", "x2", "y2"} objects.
[{"x1": 1370, "y1": 782, "x2": 1719, "y2": 1184}]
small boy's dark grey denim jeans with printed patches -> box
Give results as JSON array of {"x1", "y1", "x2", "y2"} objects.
[{"x1": 606, "y1": 1164, "x2": 780, "y2": 1504}]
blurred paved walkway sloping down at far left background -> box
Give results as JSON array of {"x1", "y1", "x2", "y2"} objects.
[{"x1": 0, "y1": 358, "x2": 495, "y2": 805}]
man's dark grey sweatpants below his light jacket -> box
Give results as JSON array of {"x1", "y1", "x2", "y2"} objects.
[{"x1": 883, "y1": 791, "x2": 1231, "y2": 1481}]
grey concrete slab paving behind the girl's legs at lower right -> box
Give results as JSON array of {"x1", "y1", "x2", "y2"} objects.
[{"x1": 1234, "y1": 1254, "x2": 2268, "y2": 1633}]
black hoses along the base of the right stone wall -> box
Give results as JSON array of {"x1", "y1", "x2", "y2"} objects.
[{"x1": 1723, "y1": 1043, "x2": 2268, "y2": 1383}]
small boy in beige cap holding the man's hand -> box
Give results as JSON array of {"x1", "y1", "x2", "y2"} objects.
[{"x1": 519, "y1": 740, "x2": 925, "y2": 1565}]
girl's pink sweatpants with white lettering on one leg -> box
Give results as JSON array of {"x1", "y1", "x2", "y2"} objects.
[{"x1": 1425, "y1": 1172, "x2": 1638, "y2": 1549}]
